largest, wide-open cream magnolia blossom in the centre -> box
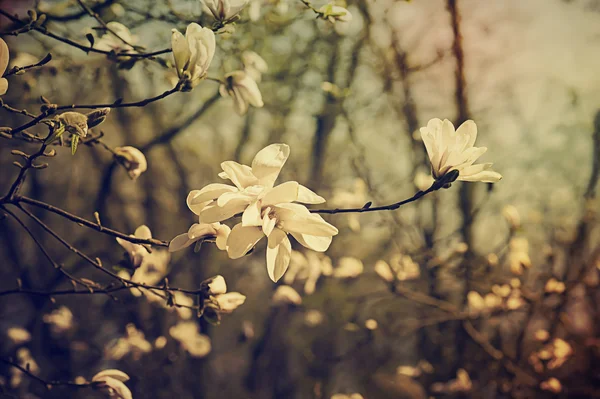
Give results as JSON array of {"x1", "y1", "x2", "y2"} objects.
[{"x1": 188, "y1": 144, "x2": 338, "y2": 281}]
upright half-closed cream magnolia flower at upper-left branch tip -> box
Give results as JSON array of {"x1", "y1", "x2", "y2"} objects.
[{"x1": 171, "y1": 23, "x2": 216, "y2": 91}]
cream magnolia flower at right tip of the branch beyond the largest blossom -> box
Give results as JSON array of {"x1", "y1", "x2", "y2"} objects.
[{"x1": 421, "y1": 118, "x2": 502, "y2": 183}]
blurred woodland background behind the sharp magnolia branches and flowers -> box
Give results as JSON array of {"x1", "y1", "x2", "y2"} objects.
[{"x1": 0, "y1": 0, "x2": 600, "y2": 399}]
